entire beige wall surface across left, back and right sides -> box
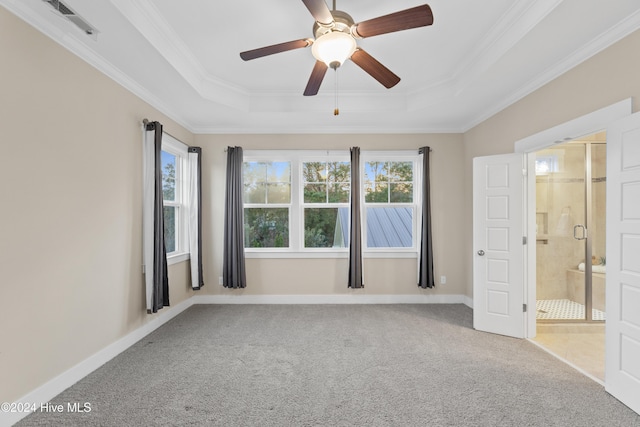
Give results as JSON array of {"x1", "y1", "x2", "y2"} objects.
[{"x1": 5, "y1": 0, "x2": 640, "y2": 410}]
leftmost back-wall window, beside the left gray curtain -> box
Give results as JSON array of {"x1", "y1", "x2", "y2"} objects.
[{"x1": 243, "y1": 161, "x2": 291, "y2": 248}]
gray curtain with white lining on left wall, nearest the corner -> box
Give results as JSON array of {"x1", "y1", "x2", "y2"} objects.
[{"x1": 188, "y1": 147, "x2": 204, "y2": 290}]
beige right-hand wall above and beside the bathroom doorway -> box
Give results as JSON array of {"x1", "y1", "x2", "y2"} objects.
[{"x1": 463, "y1": 31, "x2": 640, "y2": 296}]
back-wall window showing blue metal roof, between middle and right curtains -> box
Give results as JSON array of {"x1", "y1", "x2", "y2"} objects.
[{"x1": 363, "y1": 155, "x2": 417, "y2": 249}]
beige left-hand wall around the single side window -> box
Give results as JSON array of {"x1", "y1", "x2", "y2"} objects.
[{"x1": 0, "y1": 7, "x2": 193, "y2": 402}]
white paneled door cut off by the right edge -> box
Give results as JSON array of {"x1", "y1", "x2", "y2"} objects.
[{"x1": 605, "y1": 113, "x2": 640, "y2": 413}]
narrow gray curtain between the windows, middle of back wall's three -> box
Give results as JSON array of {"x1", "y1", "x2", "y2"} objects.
[{"x1": 348, "y1": 147, "x2": 364, "y2": 288}]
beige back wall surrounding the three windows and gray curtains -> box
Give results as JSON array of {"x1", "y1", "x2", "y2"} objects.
[{"x1": 196, "y1": 134, "x2": 465, "y2": 295}]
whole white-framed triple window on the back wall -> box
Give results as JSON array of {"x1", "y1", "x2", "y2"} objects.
[{"x1": 243, "y1": 150, "x2": 418, "y2": 257}]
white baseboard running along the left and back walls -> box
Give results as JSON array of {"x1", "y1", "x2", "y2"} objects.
[{"x1": 0, "y1": 291, "x2": 473, "y2": 427}]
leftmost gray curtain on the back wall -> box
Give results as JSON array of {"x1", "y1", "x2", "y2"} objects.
[{"x1": 222, "y1": 147, "x2": 247, "y2": 288}]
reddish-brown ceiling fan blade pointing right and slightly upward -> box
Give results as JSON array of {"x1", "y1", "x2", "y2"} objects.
[{"x1": 354, "y1": 4, "x2": 433, "y2": 38}]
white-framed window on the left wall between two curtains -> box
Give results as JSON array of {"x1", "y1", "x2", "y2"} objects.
[{"x1": 161, "y1": 133, "x2": 188, "y2": 263}]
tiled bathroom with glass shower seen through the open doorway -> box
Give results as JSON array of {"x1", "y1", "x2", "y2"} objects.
[{"x1": 536, "y1": 132, "x2": 606, "y2": 380}]
